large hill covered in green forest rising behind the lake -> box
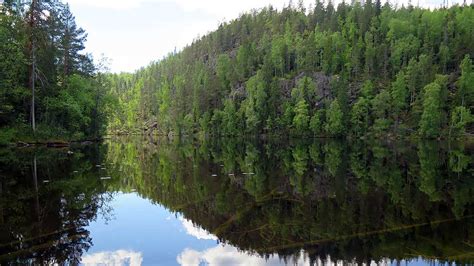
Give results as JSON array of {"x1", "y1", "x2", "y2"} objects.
[{"x1": 109, "y1": 0, "x2": 474, "y2": 138}]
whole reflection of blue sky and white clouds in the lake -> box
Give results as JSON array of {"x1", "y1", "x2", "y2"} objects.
[{"x1": 82, "y1": 194, "x2": 436, "y2": 266}]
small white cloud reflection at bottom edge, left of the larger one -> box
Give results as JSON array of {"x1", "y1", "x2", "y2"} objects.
[{"x1": 81, "y1": 250, "x2": 143, "y2": 266}]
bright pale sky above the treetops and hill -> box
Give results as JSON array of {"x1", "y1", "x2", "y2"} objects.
[{"x1": 67, "y1": 0, "x2": 462, "y2": 72}]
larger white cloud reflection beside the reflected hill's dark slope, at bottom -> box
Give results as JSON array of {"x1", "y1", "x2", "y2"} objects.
[{"x1": 176, "y1": 245, "x2": 309, "y2": 266}]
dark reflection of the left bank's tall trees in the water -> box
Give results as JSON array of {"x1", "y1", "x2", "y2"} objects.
[{"x1": 0, "y1": 148, "x2": 110, "y2": 265}]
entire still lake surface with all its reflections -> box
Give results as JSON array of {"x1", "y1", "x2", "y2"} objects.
[{"x1": 0, "y1": 138, "x2": 474, "y2": 265}]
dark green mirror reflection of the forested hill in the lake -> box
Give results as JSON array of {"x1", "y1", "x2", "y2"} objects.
[{"x1": 107, "y1": 139, "x2": 474, "y2": 262}]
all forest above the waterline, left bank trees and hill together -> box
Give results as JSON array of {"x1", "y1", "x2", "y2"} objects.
[{"x1": 0, "y1": 0, "x2": 474, "y2": 144}]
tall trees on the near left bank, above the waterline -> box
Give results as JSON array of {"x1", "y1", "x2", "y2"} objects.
[{"x1": 0, "y1": 0, "x2": 108, "y2": 142}]
